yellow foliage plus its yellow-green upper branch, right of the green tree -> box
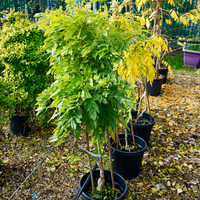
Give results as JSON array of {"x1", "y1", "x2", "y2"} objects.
[{"x1": 112, "y1": 11, "x2": 170, "y2": 83}]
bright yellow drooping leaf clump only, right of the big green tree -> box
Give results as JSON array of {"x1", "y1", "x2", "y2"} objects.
[{"x1": 117, "y1": 35, "x2": 168, "y2": 83}]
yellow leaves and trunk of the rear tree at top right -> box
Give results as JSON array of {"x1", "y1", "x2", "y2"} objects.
[{"x1": 135, "y1": 0, "x2": 200, "y2": 76}]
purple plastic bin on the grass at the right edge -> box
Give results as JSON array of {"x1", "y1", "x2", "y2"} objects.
[{"x1": 183, "y1": 48, "x2": 200, "y2": 68}]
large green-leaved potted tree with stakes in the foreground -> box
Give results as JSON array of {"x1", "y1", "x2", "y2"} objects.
[{"x1": 37, "y1": 2, "x2": 141, "y2": 199}]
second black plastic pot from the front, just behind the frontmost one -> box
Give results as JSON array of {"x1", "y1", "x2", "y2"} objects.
[{"x1": 110, "y1": 134, "x2": 147, "y2": 179}]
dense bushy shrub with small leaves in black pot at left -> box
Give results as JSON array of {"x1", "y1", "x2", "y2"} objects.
[{"x1": 0, "y1": 11, "x2": 51, "y2": 135}]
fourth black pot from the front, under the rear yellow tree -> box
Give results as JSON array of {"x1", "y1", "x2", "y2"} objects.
[{"x1": 147, "y1": 74, "x2": 164, "y2": 96}]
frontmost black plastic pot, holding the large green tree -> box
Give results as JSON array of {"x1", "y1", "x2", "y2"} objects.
[{"x1": 78, "y1": 170, "x2": 127, "y2": 200}]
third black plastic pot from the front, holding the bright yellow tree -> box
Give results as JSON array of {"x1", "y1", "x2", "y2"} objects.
[{"x1": 127, "y1": 111, "x2": 155, "y2": 145}]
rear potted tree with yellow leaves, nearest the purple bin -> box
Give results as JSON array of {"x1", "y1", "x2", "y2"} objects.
[{"x1": 136, "y1": 0, "x2": 199, "y2": 96}]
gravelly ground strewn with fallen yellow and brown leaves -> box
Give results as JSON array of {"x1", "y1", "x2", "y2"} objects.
[{"x1": 0, "y1": 70, "x2": 200, "y2": 200}]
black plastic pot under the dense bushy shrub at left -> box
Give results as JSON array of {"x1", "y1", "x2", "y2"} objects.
[{"x1": 10, "y1": 115, "x2": 31, "y2": 136}]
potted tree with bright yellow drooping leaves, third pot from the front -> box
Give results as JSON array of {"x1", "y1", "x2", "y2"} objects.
[{"x1": 116, "y1": 7, "x2": 165, "y2": 144}]
